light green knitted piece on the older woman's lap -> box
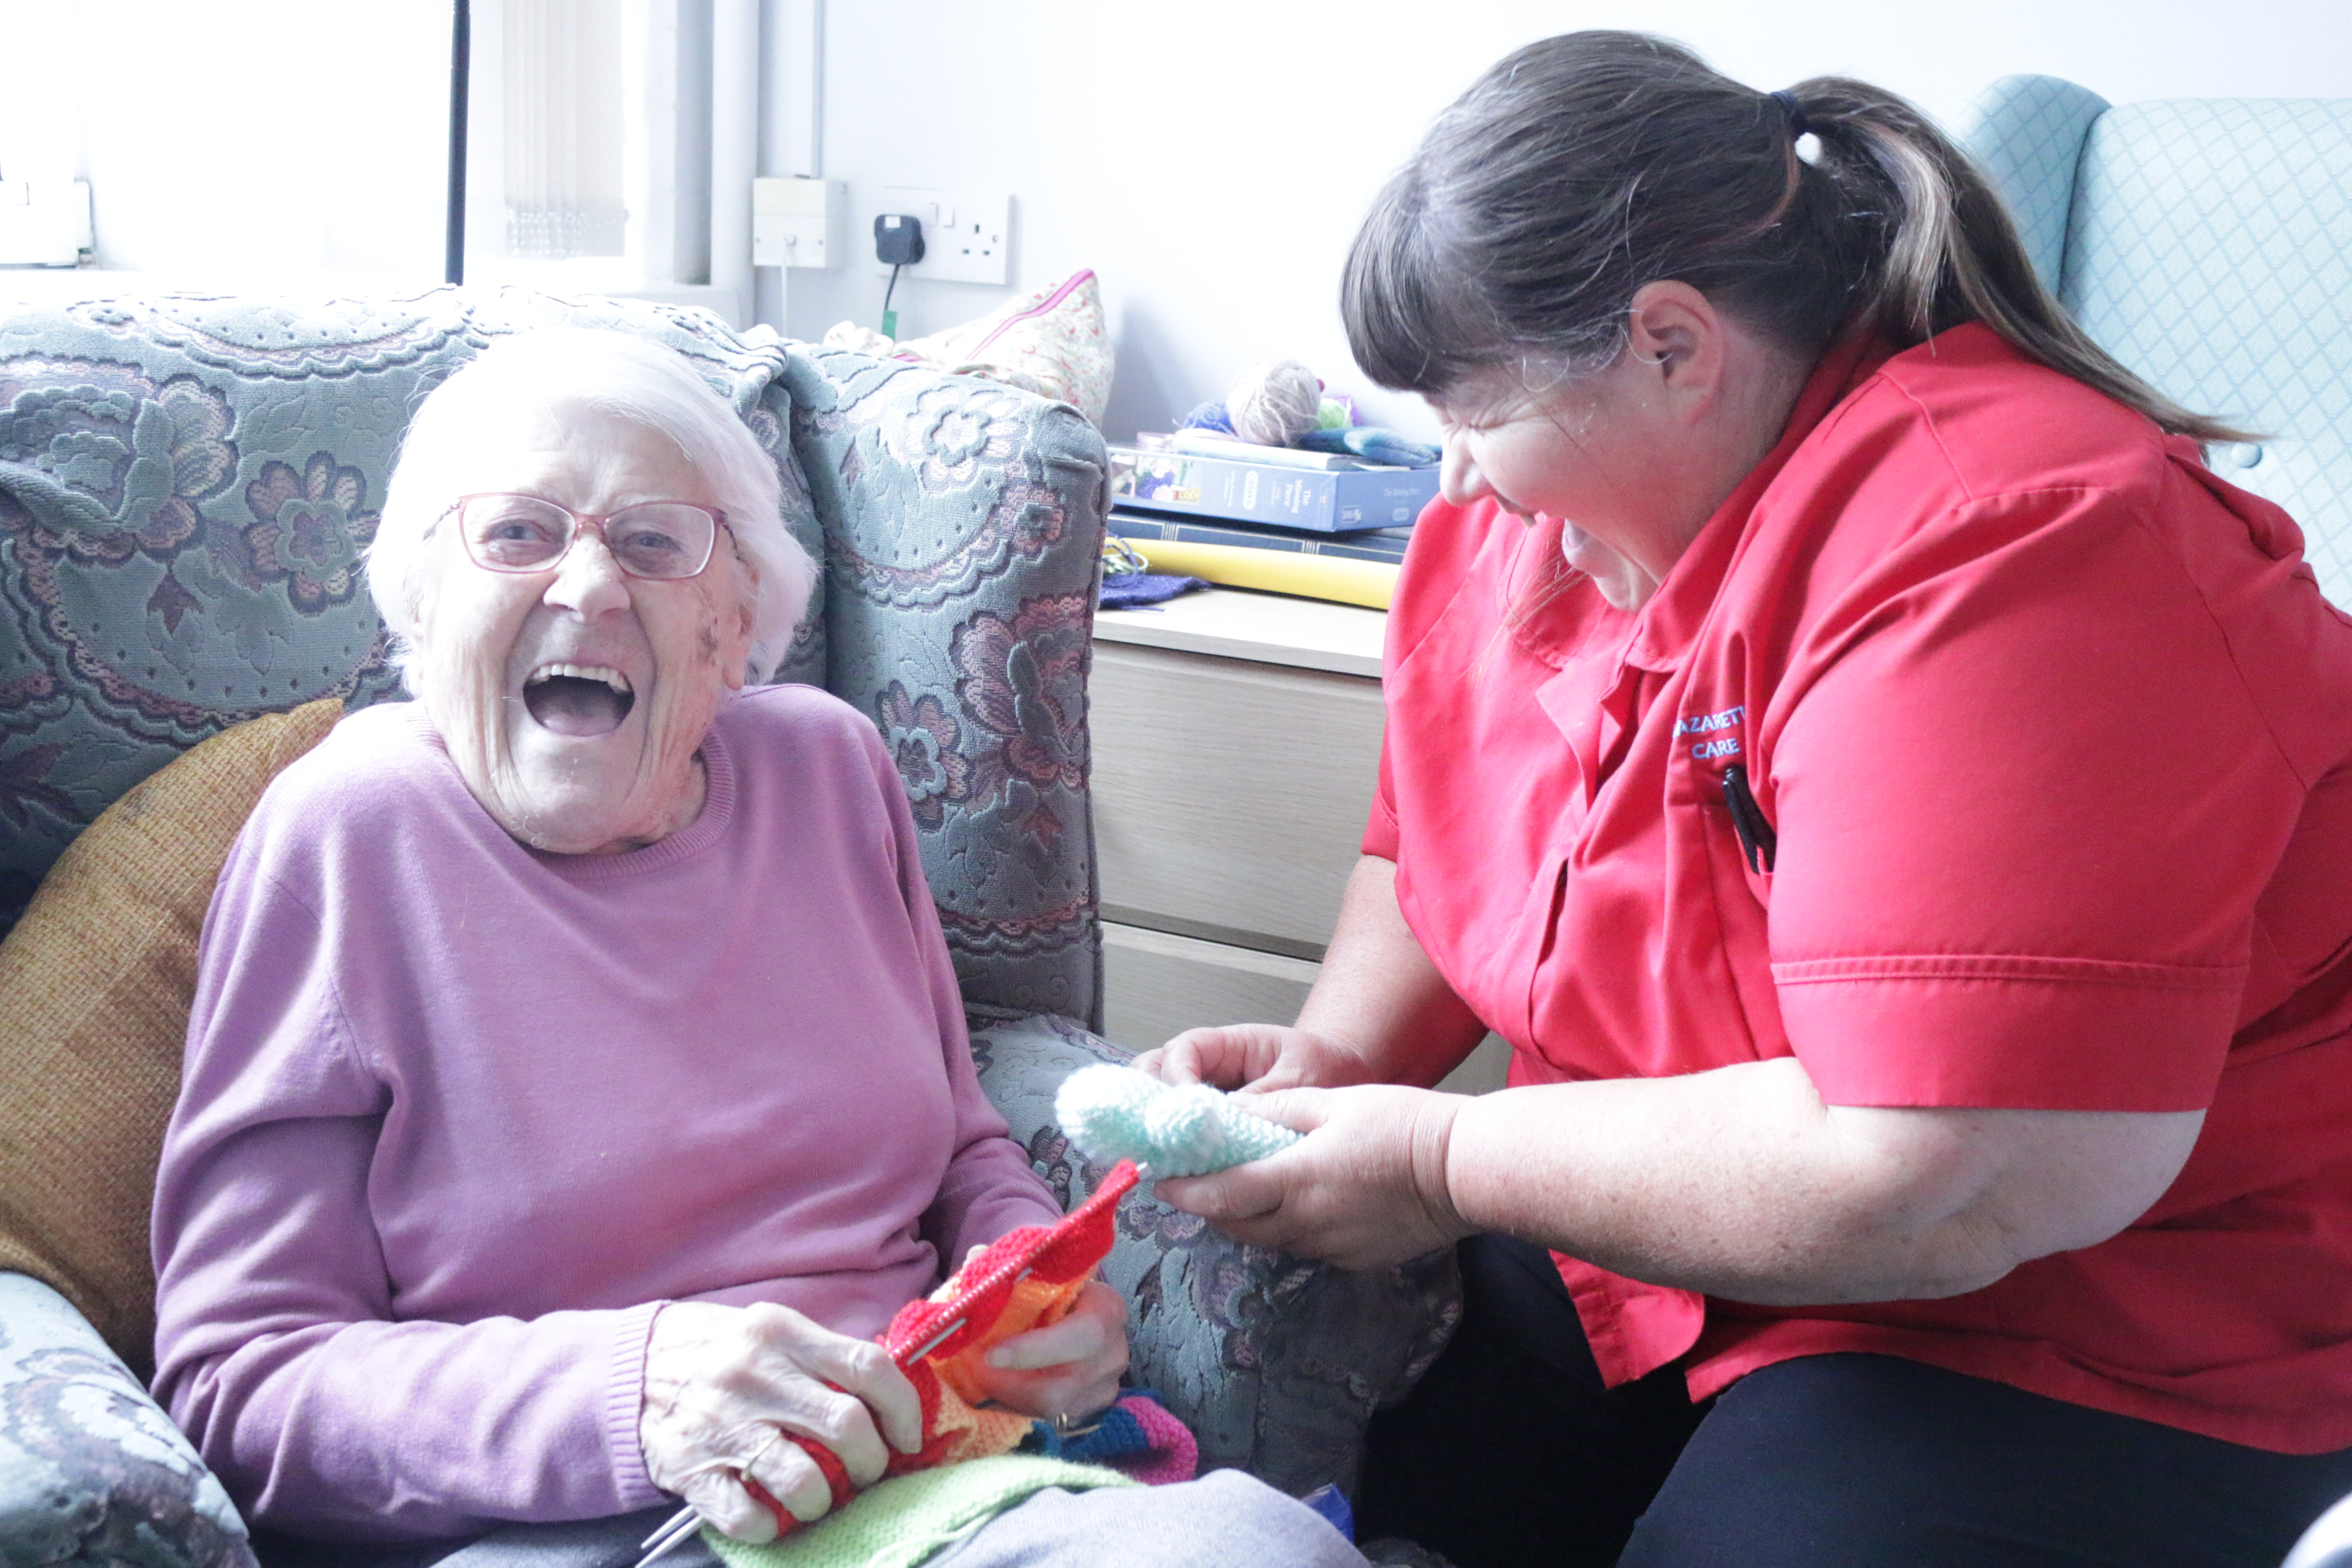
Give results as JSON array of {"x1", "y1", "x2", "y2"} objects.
[{"x1": 703, "y1": 1453, "x2": 1143, "y2": 1568}]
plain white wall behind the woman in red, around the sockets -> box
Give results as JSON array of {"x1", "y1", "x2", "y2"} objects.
[{"x1": 783, "y1": 0, "x2": 2352, "y2": 440}]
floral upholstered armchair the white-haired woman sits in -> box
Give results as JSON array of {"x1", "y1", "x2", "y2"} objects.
[{"x1": 0, "y1": 289, "x2": 1456, "y2": 1568}]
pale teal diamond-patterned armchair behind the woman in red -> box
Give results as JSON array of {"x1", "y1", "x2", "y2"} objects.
[{"x1": 1964, "y1": 75, "x2": 2352, "y2": 606}]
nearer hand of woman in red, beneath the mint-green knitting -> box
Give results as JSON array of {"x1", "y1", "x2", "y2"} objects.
[{"x1": 1157, "y1": 1090, "x2": 1472, "y2": 1269}]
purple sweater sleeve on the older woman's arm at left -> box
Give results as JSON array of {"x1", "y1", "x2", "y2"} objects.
[{"x1": 155, "y1": 844, "x2": 661, "y2": 1540}]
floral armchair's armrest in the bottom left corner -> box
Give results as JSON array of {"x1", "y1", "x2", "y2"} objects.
[{"x1": 0, "y1": 1272, "x2": 254, "y2": 1568}]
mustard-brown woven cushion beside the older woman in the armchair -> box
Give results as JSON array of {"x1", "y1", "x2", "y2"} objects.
[{"x1": 0, "y1": 698, "x2": 343, "y2": 1378}]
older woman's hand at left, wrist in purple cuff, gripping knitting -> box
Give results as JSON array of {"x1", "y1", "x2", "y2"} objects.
[{"x1": 637, "y1": 1302, "x2": 922, "y2": 1544}]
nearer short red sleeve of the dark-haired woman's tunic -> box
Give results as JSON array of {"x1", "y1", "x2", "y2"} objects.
[{"x1": 1759, "y1": 480, "x2": 2305, "y2": 1112}]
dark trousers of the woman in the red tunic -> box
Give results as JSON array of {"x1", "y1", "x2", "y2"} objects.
[{"x1": 1355, "y1": 1237, "x2": 2352, "y2": 1568}]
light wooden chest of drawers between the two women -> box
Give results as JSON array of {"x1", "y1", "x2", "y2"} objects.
[{"x1": 1089, "y1": 588, "x2": 1505, "y2": 1091}]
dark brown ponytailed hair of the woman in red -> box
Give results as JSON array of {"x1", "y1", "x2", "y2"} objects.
[{"x1": 1341, "y1": 31, "x2": 2253, "y2": 442}]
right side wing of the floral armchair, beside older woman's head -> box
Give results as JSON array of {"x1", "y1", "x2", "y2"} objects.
[{"x1": 778, "y1": 343, "x2": 1108, "y2": 1018}]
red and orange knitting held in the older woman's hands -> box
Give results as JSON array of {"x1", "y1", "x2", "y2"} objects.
[{"x1": 734, "y1": 1159, "x2": 1136, "y2": 1537}]
